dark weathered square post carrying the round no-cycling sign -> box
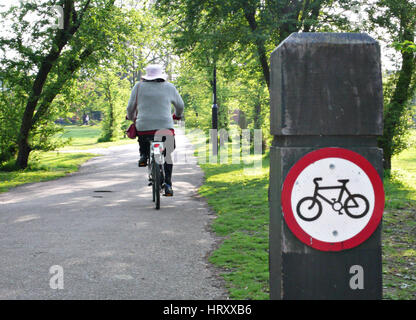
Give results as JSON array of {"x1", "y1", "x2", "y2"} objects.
[{"x1": 269, "y1": 33, "x2": 384, "y2": 299}]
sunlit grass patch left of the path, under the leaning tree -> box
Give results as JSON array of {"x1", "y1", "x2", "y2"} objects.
[{"x1": 0, "y1": 152, "x2": 97, "y2": 192}]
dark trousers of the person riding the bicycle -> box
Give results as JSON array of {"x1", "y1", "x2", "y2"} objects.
[{"x1": 138, "y1": 135, "x2": 176, "y2": 186}]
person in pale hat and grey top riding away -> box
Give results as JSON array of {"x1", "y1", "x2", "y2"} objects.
[{"x1": 126, "y1": 64, "x2": 184, "y2": 196}]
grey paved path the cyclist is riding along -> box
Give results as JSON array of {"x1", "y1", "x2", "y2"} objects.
[{"x1": 0, "y1": 130, "x2": 227, "y2": 299}]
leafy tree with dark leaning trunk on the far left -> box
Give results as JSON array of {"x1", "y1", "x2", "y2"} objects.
[{"x1": 0, "y1": 0, "x2": 139, "y2": 169}]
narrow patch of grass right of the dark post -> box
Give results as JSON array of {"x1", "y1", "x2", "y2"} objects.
[{"x1": 382, "y1": 130, "x2": 416, "y2": 300}]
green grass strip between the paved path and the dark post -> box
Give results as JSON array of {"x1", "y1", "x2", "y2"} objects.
[{"x1": 190, "y1": 130, "x2": 269, "y2": 299}]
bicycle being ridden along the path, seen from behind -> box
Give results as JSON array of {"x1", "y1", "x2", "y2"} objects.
[{"x1": 147, "y1": 141, "x2": 165, "y2": 210}]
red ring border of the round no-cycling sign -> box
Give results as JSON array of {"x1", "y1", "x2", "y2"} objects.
[{"x1": 281, "y1": 147, "x2": 385, "y2": 251}]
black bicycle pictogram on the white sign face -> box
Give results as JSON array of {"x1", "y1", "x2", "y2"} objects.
[{"x1": 296, "y1": 178, "x2": 370, "y2": 221}]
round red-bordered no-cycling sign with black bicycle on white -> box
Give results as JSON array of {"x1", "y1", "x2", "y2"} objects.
[{"x1": 282, "y1": 148, "x2": 384, "y2": 251}]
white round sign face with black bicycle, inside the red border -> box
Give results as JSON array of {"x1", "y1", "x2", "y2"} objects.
[{"x1": 290, "y1": 157, "x2": 375, "y2": 243}]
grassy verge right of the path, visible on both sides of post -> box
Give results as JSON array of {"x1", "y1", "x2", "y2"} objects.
[{"x1": 191, "y1": 132, "x2": 416, "y2": 299}]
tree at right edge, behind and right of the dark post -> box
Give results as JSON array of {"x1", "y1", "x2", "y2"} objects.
[{"x1": 366, "y1": 0, "x2": 416, "y2": 170}]
